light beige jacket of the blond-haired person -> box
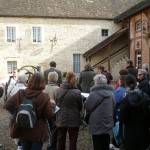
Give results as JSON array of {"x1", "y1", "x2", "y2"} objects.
[{"x1": 43, "y1": 83, "x2": 59, "y2": 100}]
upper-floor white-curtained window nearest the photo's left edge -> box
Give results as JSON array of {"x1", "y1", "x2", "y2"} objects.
[{"x1": 7, "y1": 27, "x2": 16, "y2": 42}]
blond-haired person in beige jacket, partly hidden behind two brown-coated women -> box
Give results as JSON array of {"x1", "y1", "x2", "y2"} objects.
[{"x1": 43, "y1": 71, "x2": 59, "y2": 150}]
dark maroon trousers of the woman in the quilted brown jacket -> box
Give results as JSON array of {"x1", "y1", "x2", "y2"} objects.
[{"x1": 57, "y1": 127, "x2": 79, "y2": 150}]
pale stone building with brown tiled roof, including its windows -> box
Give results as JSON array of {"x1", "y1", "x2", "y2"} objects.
[{"x1": 0, "y1": 0, "x2": 144, "y2": 78}]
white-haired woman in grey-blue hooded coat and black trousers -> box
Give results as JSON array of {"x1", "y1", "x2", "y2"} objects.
[{"x1": 84, "y1": 74, "x2": 115, "y2": 150}]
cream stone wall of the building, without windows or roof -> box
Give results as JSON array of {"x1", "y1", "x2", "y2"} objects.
[{"x1": 0, "y1": 17, "x2": 120, "y2": 78}]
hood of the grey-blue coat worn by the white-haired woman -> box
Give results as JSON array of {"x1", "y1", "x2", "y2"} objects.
[{"x1": 90, "y1": 84, "x2": 114, "y2": 98}]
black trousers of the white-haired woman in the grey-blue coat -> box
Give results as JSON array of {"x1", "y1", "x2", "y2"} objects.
[{"x1": 92, "y1": 134, "x2": 110, "y2": 150}]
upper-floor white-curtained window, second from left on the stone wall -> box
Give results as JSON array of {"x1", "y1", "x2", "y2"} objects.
[{"x1": 32, "y1": 27, "x2": 41, "y2": 43}]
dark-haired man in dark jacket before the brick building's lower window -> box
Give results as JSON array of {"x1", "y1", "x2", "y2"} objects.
[{"x1": 125, "y1": 59, "x2": 138, "y2": 78}]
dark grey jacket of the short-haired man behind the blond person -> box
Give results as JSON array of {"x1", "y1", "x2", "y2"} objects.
[{"x1": 44, "y1": 67, "x2": 62, "y2": 85}]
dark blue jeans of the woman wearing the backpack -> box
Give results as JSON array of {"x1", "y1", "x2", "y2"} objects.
[{"x1": 21, "y1": 139, "x2": 43, "y2": 150}]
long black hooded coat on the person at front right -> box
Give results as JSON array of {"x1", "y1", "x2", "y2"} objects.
[{"x1": 119, "y1": 89, "x2": 149, "y2": 150}]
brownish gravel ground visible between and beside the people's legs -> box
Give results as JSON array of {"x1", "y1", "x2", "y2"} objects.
[{"x1": 0, "y1": 101, "x2": 93, "y2": 150}]
